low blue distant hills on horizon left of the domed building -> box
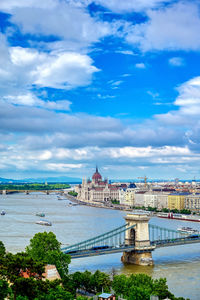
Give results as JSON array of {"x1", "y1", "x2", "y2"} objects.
[{"x1": 0, "y1": 176, "x2": 82, "y2": 183}]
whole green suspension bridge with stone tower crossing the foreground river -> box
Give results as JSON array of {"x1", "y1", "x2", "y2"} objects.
[{"x1": 62, "y1": 214, "x2": 200, "y2": 265}]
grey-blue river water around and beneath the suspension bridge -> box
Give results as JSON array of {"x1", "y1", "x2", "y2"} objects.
[{"x1": 0, "y1": 193, "x2": 200, "y2": 300}]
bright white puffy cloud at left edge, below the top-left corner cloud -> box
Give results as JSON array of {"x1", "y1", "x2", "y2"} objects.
[{"x1": 0, "y1": 41, "x2": 99, "y2": 110}]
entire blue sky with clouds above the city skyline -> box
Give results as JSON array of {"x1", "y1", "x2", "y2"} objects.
[{"x1": 0, "y1": 0, "x2": 200, "y2": 180}]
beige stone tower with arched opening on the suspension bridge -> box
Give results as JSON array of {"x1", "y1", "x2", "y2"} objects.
[{"x1": 121, "y1": 214, "x2": 155, "y2": 265}]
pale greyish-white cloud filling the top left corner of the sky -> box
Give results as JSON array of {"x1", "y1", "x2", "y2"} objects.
[{"x1": 0, "y1": 0, "x2": 116, "y2": 50}]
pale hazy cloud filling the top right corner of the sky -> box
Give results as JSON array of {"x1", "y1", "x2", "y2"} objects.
[{"x1": 126, "y1": 2, "x2": 200, "y2": 51}]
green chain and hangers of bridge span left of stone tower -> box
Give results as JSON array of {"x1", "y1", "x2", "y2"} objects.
[{"x1": 62, "y1": 224, "x2": 135, "y2": 253}]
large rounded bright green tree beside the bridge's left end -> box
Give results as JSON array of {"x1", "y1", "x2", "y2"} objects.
[{"x1": 26, "y1": 232, "x2": 71, "y2": 278}]
